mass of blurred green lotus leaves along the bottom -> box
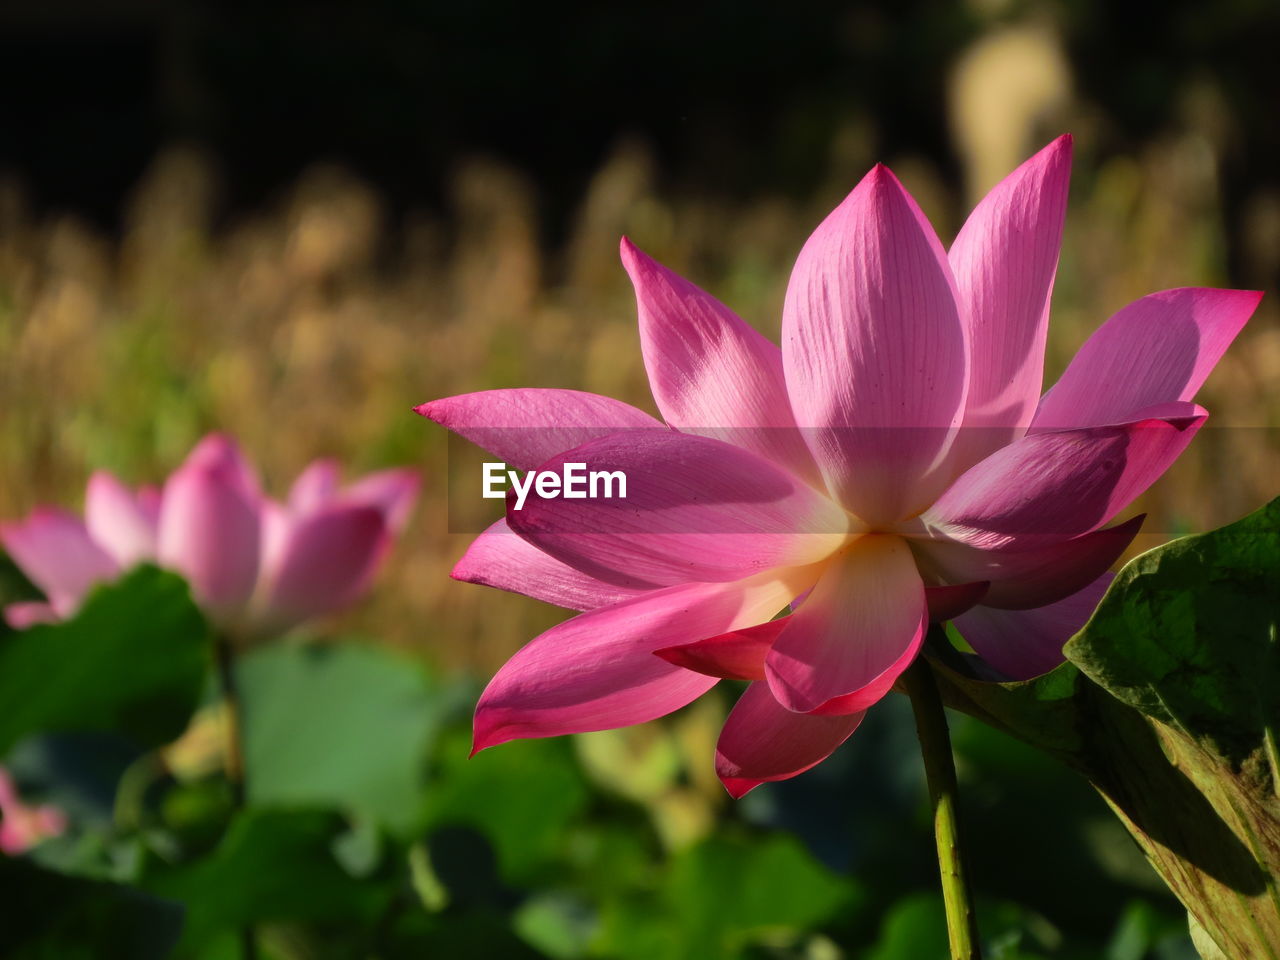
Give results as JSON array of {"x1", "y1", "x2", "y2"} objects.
[{"x1": 0, "y1": 567, "x2": 1218, "y2": 960}]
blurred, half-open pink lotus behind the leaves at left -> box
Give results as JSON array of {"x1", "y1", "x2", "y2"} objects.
[{"x1": 0, "y1": 434, "x2": 417, "y2": 636}]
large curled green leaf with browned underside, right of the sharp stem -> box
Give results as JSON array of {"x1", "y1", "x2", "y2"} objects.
[{"x1": 933, "y1": 499, "x2": 1280, "y2": 957}]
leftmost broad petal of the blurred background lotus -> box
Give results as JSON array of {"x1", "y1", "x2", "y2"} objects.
[{"x1": 0, "y1": 507, "x2": 120, "y2": 616}]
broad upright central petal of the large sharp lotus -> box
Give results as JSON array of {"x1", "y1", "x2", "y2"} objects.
[{"x1": 782, "y1": 166, "x2": 966, "y2": 525}]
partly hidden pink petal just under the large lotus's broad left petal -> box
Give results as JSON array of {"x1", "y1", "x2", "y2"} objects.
[{"x1": 449, "y1": 517, "x2": 652, "y2": 611}]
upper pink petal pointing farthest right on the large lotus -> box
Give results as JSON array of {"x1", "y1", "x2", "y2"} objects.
[{"x1": 1033, "y1": 287, "x2": 1262, "y2": 431}]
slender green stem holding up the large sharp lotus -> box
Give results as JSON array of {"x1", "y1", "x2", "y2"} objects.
[{"x1": 902, "y1": 655, "x2": 982, "y2": 960}]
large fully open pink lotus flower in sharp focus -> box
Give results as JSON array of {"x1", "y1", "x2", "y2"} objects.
[{"x1": 419, "y1": 137, "x2": 1261, "y2": 796}]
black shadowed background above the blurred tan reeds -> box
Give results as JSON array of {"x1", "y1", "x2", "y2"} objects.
[{"x1": 0, "y1": 0, "x2": 1280, "y2": 259}]
